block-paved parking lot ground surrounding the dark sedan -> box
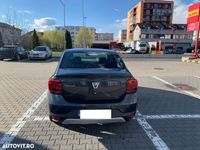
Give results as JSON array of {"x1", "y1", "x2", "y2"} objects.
[{"x1": 0, "y1": 58, "x2": 200, "y2": 150}]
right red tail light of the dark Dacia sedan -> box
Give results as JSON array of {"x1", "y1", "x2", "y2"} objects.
[{"x1": 126, "y1": 79, "x2": 138, "y2": 94}]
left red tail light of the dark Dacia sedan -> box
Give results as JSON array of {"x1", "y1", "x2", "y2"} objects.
[{"x1": 48, "y1": 78, "x2": 63, "y2": 95}]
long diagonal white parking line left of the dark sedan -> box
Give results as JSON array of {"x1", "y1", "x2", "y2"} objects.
[{"x1": 0, "y1": 90, "x2": 47, "y2": 150}]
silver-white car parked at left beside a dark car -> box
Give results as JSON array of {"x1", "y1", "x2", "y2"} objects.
[{"x1": 28, "y1": 46, "x2": 52, "y2": 59}]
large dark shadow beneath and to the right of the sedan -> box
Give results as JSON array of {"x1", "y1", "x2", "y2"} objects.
[{"x1": 55, "y1": 87, "x2": 200, "y2": 150}]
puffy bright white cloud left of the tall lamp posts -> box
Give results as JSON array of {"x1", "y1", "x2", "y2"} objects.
[{"x1": 34, "y1": 17, "x2": 56, "y2": 28}]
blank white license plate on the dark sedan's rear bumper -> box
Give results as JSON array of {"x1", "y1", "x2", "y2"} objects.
[{"x1": 80, "y1": 110, "x2": 111, "y2": 119}]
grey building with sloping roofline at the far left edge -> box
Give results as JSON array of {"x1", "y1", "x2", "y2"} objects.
[{"x1": 0, "y1": 23, "x2": 22, "y2": 45}]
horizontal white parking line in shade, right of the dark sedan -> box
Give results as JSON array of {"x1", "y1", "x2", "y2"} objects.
[{"x1": 142, "y1": 114, "x2": 200, "y2": 119}]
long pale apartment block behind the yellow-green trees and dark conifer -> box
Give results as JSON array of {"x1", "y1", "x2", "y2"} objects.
[{"x1": 55, "y1": 26, "x2": 96, "y2": 47}]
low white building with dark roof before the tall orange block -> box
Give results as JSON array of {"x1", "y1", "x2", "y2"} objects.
[{"x1": 126, "y1": 24, "x2": 193, "y2": 51}]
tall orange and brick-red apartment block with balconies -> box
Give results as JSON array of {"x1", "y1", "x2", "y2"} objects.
[{"x1": 127, "y1": 0, "x2": 174, "y2": 41}]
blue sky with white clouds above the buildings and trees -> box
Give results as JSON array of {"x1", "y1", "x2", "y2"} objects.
[{"x1": 0, "y1": 0, "x2": 199, "y2": 36}]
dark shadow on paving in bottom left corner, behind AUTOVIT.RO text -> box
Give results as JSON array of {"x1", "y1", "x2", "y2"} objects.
[{"x1": 0, "y1": 132, "x2": 47, "y2": 150}]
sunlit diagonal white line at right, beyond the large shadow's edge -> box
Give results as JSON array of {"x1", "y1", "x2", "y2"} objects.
[{"x1": 152, "y1": 76, "x2": 200, "y2": 99}]
